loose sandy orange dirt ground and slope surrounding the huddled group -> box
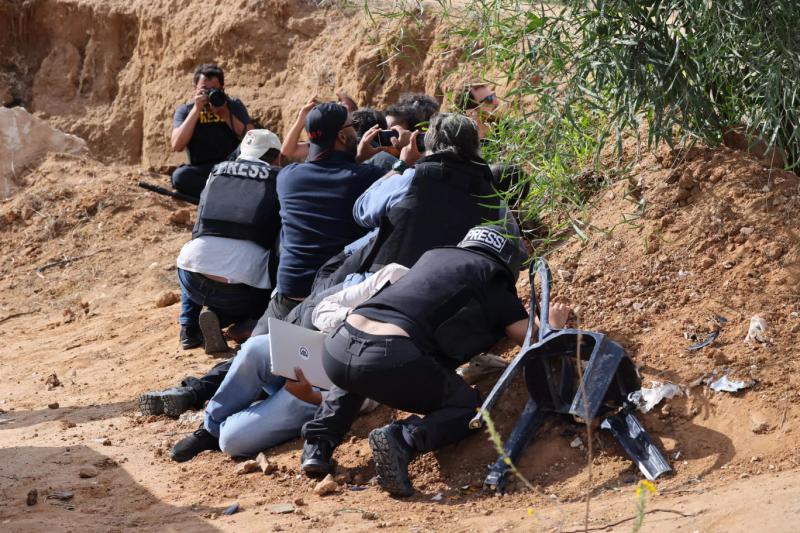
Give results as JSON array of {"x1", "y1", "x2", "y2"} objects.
[{"x1": 0, "y1": 149, "x2": 800, "y2": 531}]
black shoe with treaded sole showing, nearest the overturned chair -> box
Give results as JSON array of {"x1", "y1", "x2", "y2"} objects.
[{"x1": 369, "y1": 424, "x2": 414, "y2": 496}]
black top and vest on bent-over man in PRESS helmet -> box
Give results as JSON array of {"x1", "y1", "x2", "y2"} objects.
[{"x1": 353, "y1": 247, "x2": 528, "y2": 357}]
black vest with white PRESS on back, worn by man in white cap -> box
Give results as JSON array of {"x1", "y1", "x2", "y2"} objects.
[{"x1": 192, "y1": 160, "x2": 281, "y2": 250}]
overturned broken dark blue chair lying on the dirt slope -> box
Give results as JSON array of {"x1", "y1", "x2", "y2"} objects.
[{"x1": 470, "y1": 259, "x2": 671, "y2": 491}]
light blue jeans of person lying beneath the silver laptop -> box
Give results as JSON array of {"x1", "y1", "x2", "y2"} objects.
[{"x1": 203, "y1": 335, "x2": 317, "y2": 457}]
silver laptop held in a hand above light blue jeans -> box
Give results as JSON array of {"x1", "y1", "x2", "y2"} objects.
[{"x1": 267, "y1": 318, "x2": 333, "y2": 390}]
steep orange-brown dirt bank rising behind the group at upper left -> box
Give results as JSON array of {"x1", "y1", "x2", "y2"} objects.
[{"x1": 0, "y1": 0, "x2": 457, "y2": 167}]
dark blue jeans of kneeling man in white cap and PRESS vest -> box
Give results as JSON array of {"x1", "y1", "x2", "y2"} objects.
[{"x1": 178, "y1": 268, "x2": 270, "y2": 327}]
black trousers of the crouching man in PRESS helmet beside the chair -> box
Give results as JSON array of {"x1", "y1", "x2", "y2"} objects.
[{"x1": 302, "y1": 323, "x2": 480, "y2": 453}]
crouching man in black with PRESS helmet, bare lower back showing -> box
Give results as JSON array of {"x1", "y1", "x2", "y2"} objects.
[{"x1": 300, "y1": 226, "x2": 569, "y2": 496}]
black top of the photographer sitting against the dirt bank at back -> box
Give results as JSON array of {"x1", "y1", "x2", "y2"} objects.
[{"x1": 172, "y1": 98, "x2": 252, "y2": 165}]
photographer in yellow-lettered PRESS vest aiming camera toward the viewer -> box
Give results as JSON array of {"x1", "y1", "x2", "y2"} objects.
[{"x1": 171, "y1": 64, "x2": 253, "y2": 198}]
